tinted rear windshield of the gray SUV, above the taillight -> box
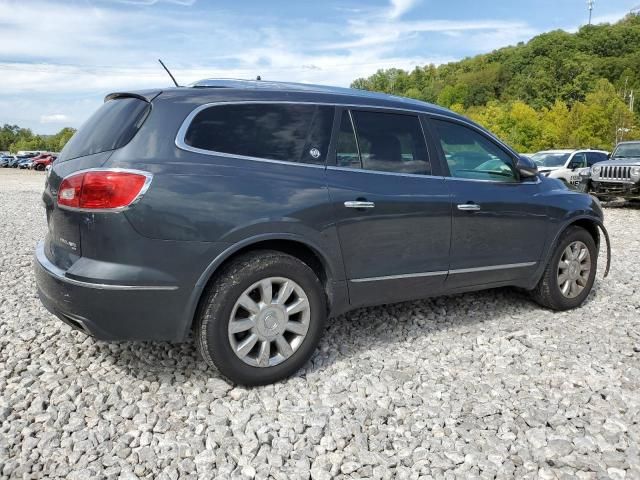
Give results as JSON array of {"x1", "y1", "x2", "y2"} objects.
[{"x1": 60, "y1": 98, "x2": 151, "y2": 161}]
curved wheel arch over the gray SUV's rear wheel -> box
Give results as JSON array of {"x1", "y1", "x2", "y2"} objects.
[{"x1": 183, "y1": 234, "x2": 338, "y2": 338}]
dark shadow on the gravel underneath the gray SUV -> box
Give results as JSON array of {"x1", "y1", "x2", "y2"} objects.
[{"x1": 93, "y1": 288, "x2": 556, "y2": 384}]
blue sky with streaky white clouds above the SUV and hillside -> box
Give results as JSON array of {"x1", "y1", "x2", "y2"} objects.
[{"x1": 0, "y1": 0, "x2": 640, "y2": 134}]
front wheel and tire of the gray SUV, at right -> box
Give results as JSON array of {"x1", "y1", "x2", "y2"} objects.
[{"x1": 531, "y1": 226, "x2": 598, "y2": 310}]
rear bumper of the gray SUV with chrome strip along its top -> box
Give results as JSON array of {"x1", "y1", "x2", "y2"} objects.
[{"x1": 34, "y1": 242, "x2": 186, "y2": 340}]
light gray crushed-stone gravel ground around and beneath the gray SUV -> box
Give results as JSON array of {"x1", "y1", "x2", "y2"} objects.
[{"x1": 0, "y1": 169, "x2": 640, "y2": 479}]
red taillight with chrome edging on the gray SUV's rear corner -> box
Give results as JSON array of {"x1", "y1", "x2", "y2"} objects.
[{"x1": 58, "y1": 170, "x2": 152, "y2": 210}]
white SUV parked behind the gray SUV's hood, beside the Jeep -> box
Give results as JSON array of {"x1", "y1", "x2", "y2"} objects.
[{"x1": 531, "y1": 149, "x2": 609, "y2": 188}]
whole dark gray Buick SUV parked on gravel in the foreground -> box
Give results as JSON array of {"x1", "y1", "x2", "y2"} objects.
[{"x1": 35, "y1": 80, "x2": 608, "y2": 385}]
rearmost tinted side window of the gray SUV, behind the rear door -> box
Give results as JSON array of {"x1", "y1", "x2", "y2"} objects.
[{"x1": 184, "y1": 104, "x2": 334, "y2": 165}]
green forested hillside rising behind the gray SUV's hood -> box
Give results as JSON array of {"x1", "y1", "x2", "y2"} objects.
[{"x1": 352, "y1": 15, "x2": 640, "y2": 152}]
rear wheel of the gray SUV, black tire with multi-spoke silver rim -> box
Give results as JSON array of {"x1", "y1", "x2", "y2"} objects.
[{"x1": 196, "y1": 250, "x2": 327, "y2": 386}]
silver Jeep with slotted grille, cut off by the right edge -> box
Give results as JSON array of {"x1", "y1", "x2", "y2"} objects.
[{"x1": 590, "y1": 141, "x2": 640, "y2": 200}]
